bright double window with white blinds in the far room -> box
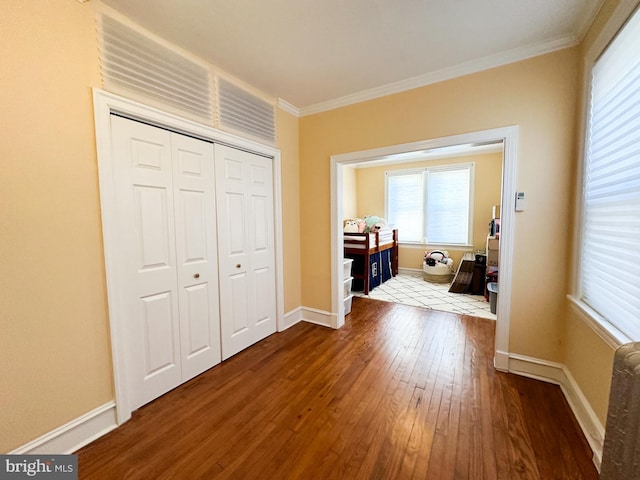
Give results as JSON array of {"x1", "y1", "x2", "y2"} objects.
[{"x1": 385, "y1": 163, "x2": 473, "y2": 245}]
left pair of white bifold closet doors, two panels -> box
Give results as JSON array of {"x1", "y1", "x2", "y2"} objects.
[{"x1": 108, "y1": 115, "x2": 221, "y2": 410}]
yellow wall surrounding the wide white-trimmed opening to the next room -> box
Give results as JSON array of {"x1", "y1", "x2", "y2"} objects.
[{"x1": 300, "y1": 48, "x2": 578, "y2": 361}]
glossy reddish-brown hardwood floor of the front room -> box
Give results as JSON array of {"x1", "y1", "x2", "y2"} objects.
[{"x1": 77, "y1": 298, "x2": 598, "y2": 480}]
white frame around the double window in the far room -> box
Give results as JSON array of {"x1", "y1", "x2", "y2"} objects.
[{"x1": 384, "y1": 162, "x2": 475, "y2": 249}]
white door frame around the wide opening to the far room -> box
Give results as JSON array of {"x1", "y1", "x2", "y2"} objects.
[{"x1": 331, "y1": 125, "x2": 519, "y2": 372}]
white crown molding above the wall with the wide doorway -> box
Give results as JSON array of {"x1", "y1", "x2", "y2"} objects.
[{"x1": 299, "y1": 35, "x2": 578, "y2": 117}]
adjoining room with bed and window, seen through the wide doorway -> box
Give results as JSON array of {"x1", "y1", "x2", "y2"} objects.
[{"x1": 342, "y1": 143, "x2": 503, "y2": 320}]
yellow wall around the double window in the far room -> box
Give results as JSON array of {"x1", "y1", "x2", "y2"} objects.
[{"x1": 356, "y1": 153, "x2": 502, "y2": 269}]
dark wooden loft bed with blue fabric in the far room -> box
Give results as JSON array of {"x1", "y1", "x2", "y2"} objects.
[{"x1": 344, "y1": 229, "x2": 398, "y2": 295}]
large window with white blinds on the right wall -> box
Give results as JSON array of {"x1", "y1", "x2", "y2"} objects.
[{"x1": 580, "y1": 3, "x2": 640, "y2": 341}]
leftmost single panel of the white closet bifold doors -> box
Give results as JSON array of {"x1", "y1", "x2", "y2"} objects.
[{"x1": 111, "y1": 116, "x2": 182, "y2": 410}]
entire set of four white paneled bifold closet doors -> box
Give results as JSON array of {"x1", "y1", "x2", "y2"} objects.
[{"x1": 107, "y1": 115, "x2": 276, "y2": 411}]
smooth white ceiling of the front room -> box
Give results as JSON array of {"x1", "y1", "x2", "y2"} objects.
[{"x1": 103, "y1": 0, "x2": 603, "y2": 112}]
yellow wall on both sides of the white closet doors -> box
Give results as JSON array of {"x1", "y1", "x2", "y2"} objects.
[{"x1": 0, "y1": 0, "x2": 301, "y2": 453}]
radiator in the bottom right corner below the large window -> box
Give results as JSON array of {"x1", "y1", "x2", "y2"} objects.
[{"x1": 600, "y1": 342, "x2": 640, "y2": 480}]
